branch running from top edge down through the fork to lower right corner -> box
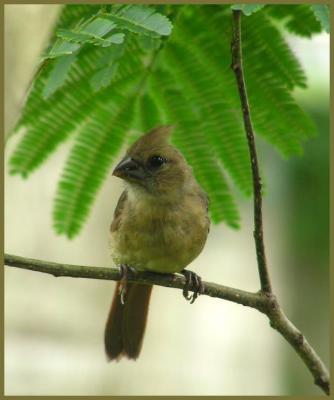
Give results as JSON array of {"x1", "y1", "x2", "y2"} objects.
[{"x1": 231, "y1": 10, "x2": 330, "y2": 395}]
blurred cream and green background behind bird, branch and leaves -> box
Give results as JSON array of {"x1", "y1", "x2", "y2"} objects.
[{"x1": 5, "y1": 5, "x2": 329, "y2": 395}]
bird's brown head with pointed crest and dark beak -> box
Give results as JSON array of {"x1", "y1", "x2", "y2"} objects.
[{"x1": 113, "y1": 126, "x2": 193, "y2": 195}]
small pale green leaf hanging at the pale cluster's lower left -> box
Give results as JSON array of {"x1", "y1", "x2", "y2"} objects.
[{"x1": 43, "y1": 53, "x2": 77, "y2": 99}]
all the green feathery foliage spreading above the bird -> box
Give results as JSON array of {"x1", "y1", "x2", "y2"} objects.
[{"x1": 10, "y1": 5, "x2": 326, "y2": 237}]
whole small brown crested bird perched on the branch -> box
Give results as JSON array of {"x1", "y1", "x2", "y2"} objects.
[{"x1": 105, "y1": 126, "x2": 210, "y2": 360}]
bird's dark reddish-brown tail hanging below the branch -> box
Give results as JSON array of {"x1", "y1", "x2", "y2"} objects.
[{"x1": 104, "y1": 282, "x2": 153, "y2": 361}]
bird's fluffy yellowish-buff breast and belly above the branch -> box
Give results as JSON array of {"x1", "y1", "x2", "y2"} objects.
[{"x1": 110, "y1": 195, "x2": 208, "y2": 273}]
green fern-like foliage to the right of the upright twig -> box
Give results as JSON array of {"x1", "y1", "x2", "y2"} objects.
[{"x1": 202, "y1": 7, "x2": 316, "y2": 157}]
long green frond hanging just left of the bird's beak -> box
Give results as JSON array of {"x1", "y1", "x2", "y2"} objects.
[{"x1": 53, "y1": 78, "x2": 134, "y2": 238}]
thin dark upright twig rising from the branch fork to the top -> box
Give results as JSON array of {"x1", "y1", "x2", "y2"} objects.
[{"x1": 232, "y1": 10, "x2": 272, "y2": 293}]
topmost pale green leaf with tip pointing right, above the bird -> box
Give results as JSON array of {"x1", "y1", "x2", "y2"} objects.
[{"x1": 102, "y1": 5, "x2": 172, "y2": 37}]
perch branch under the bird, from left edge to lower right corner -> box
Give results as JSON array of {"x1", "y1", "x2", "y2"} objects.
[{"x1": 5, "y1": 254, "x2": 329, "y2": 394}]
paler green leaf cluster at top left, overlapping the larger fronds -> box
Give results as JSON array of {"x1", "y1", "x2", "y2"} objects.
[{"x1": 43, "y1": 5, "x2": 171, "y2": 98}]
